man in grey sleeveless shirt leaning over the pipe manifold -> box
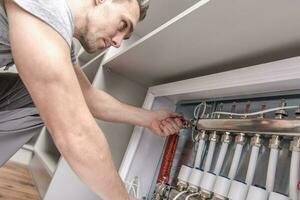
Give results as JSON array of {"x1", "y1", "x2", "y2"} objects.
[{"x1": 0, "y1": 0, "x2": 182, "y2": 200}]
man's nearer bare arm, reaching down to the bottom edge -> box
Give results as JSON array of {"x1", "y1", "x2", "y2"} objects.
[{"x1": 5, "y1": 0, "x2": 129, "y2": 200}]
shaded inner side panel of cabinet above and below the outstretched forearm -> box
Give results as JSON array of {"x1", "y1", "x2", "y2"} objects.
[{"x1": 93, "y1": 67, "x2": 147, "y2": 168}]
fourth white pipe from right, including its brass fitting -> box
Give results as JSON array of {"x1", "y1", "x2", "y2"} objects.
[{"x1": 228, "y1": 133, "x2": 246, "y2": 180}]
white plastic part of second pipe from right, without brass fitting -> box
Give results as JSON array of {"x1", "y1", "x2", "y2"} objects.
[{"x1": 266, "y1": 148, "x2": 279, "y2": 192}]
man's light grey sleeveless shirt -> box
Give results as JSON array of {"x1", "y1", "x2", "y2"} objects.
[{"x1": 0, "y1": 0, "x2": 76, "y2": 67}]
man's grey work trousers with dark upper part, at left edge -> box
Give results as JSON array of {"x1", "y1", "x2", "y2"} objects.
[{"x1": 0, "y1": 73, "x2": 43, "y2": 167}]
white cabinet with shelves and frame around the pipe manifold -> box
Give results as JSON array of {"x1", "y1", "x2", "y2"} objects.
[{"x1": 40, "y1": 0, "x2": 300, "y2": 200}]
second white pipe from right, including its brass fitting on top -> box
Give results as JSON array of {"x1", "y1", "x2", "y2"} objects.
[{"x1": 266, "y1": 135, "x2": 280, "y2": 192}]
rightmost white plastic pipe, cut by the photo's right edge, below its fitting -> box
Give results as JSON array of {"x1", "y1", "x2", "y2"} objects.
[{"x1": 289, "y1": 151, "x2": 300, "y2": 200}]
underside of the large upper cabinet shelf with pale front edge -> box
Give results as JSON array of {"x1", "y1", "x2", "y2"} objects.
[{"x1": 103, "y1": 0, "x2": 300, "y2": 86}]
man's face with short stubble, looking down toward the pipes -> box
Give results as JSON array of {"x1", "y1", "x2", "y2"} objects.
[{"x1": 78, "y1": 0, "x2": 139, "y2": 53}]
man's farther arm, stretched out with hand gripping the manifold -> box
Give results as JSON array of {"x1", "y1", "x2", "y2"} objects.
[{"x1": 74, "y1": 65, "x2": 183, "y2": 136}]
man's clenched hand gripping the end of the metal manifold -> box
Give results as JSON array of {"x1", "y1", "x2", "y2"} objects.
[{"x1": 147, "y1": 110, "x2": 184, "y2": 137}]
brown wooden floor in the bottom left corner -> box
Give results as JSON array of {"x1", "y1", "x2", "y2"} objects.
[{"x1": 0, "y1": 162, "x2": 41, "y2": 200}]
